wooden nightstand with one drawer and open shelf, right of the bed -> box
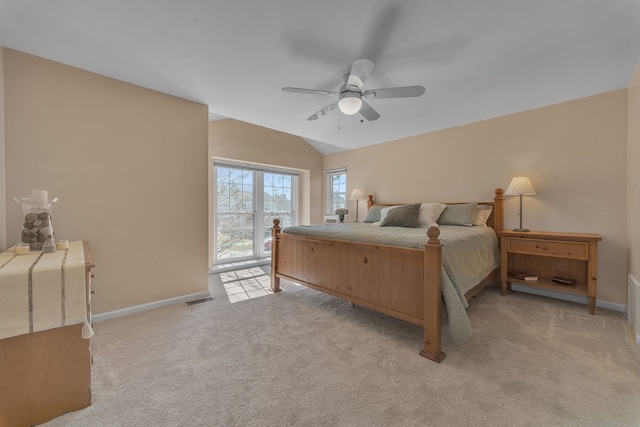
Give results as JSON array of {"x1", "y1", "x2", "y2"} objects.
[{"x1": 498, "y1": 230, "x2": 602, "y2": 314}]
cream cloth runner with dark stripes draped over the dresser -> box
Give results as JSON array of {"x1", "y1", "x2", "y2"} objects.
[{"x1": 0, "y1": 240, "x2": 93, "y2": 339}]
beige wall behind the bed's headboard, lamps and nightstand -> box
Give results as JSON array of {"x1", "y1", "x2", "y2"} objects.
[{"x1": 324, "y1": 89, "x2": 627, "y2": 304}]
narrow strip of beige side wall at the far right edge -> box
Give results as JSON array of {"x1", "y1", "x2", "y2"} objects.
[{"x1": 627, "y1": 66, "x2": 640, "y2": 282}]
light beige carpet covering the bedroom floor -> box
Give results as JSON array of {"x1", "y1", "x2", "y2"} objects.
[{"x1": 45, "y1": 267, "x2": 640, "y2": 427}]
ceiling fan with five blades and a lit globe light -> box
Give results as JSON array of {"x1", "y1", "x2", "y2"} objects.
[{"x1": 282, "y1": 59, "x2": 425, "y2": 121}]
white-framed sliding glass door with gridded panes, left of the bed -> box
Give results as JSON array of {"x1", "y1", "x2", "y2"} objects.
[{"x1": 214, "y1": 162, "x2": 297, "y2": 264}]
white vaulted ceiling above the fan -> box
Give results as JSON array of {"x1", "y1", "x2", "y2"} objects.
[{"x1": 0, "y1": 0, "x2": 640, "y2": 154}]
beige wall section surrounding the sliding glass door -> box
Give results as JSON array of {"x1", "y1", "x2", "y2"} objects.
[{"x1": 209, "y1": 119, "x2": 324, "y2": 264}]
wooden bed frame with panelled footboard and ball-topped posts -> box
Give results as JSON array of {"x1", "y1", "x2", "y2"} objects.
[{"x1": 271, "y1": 188, "x2": 504, "y2": 362}]
